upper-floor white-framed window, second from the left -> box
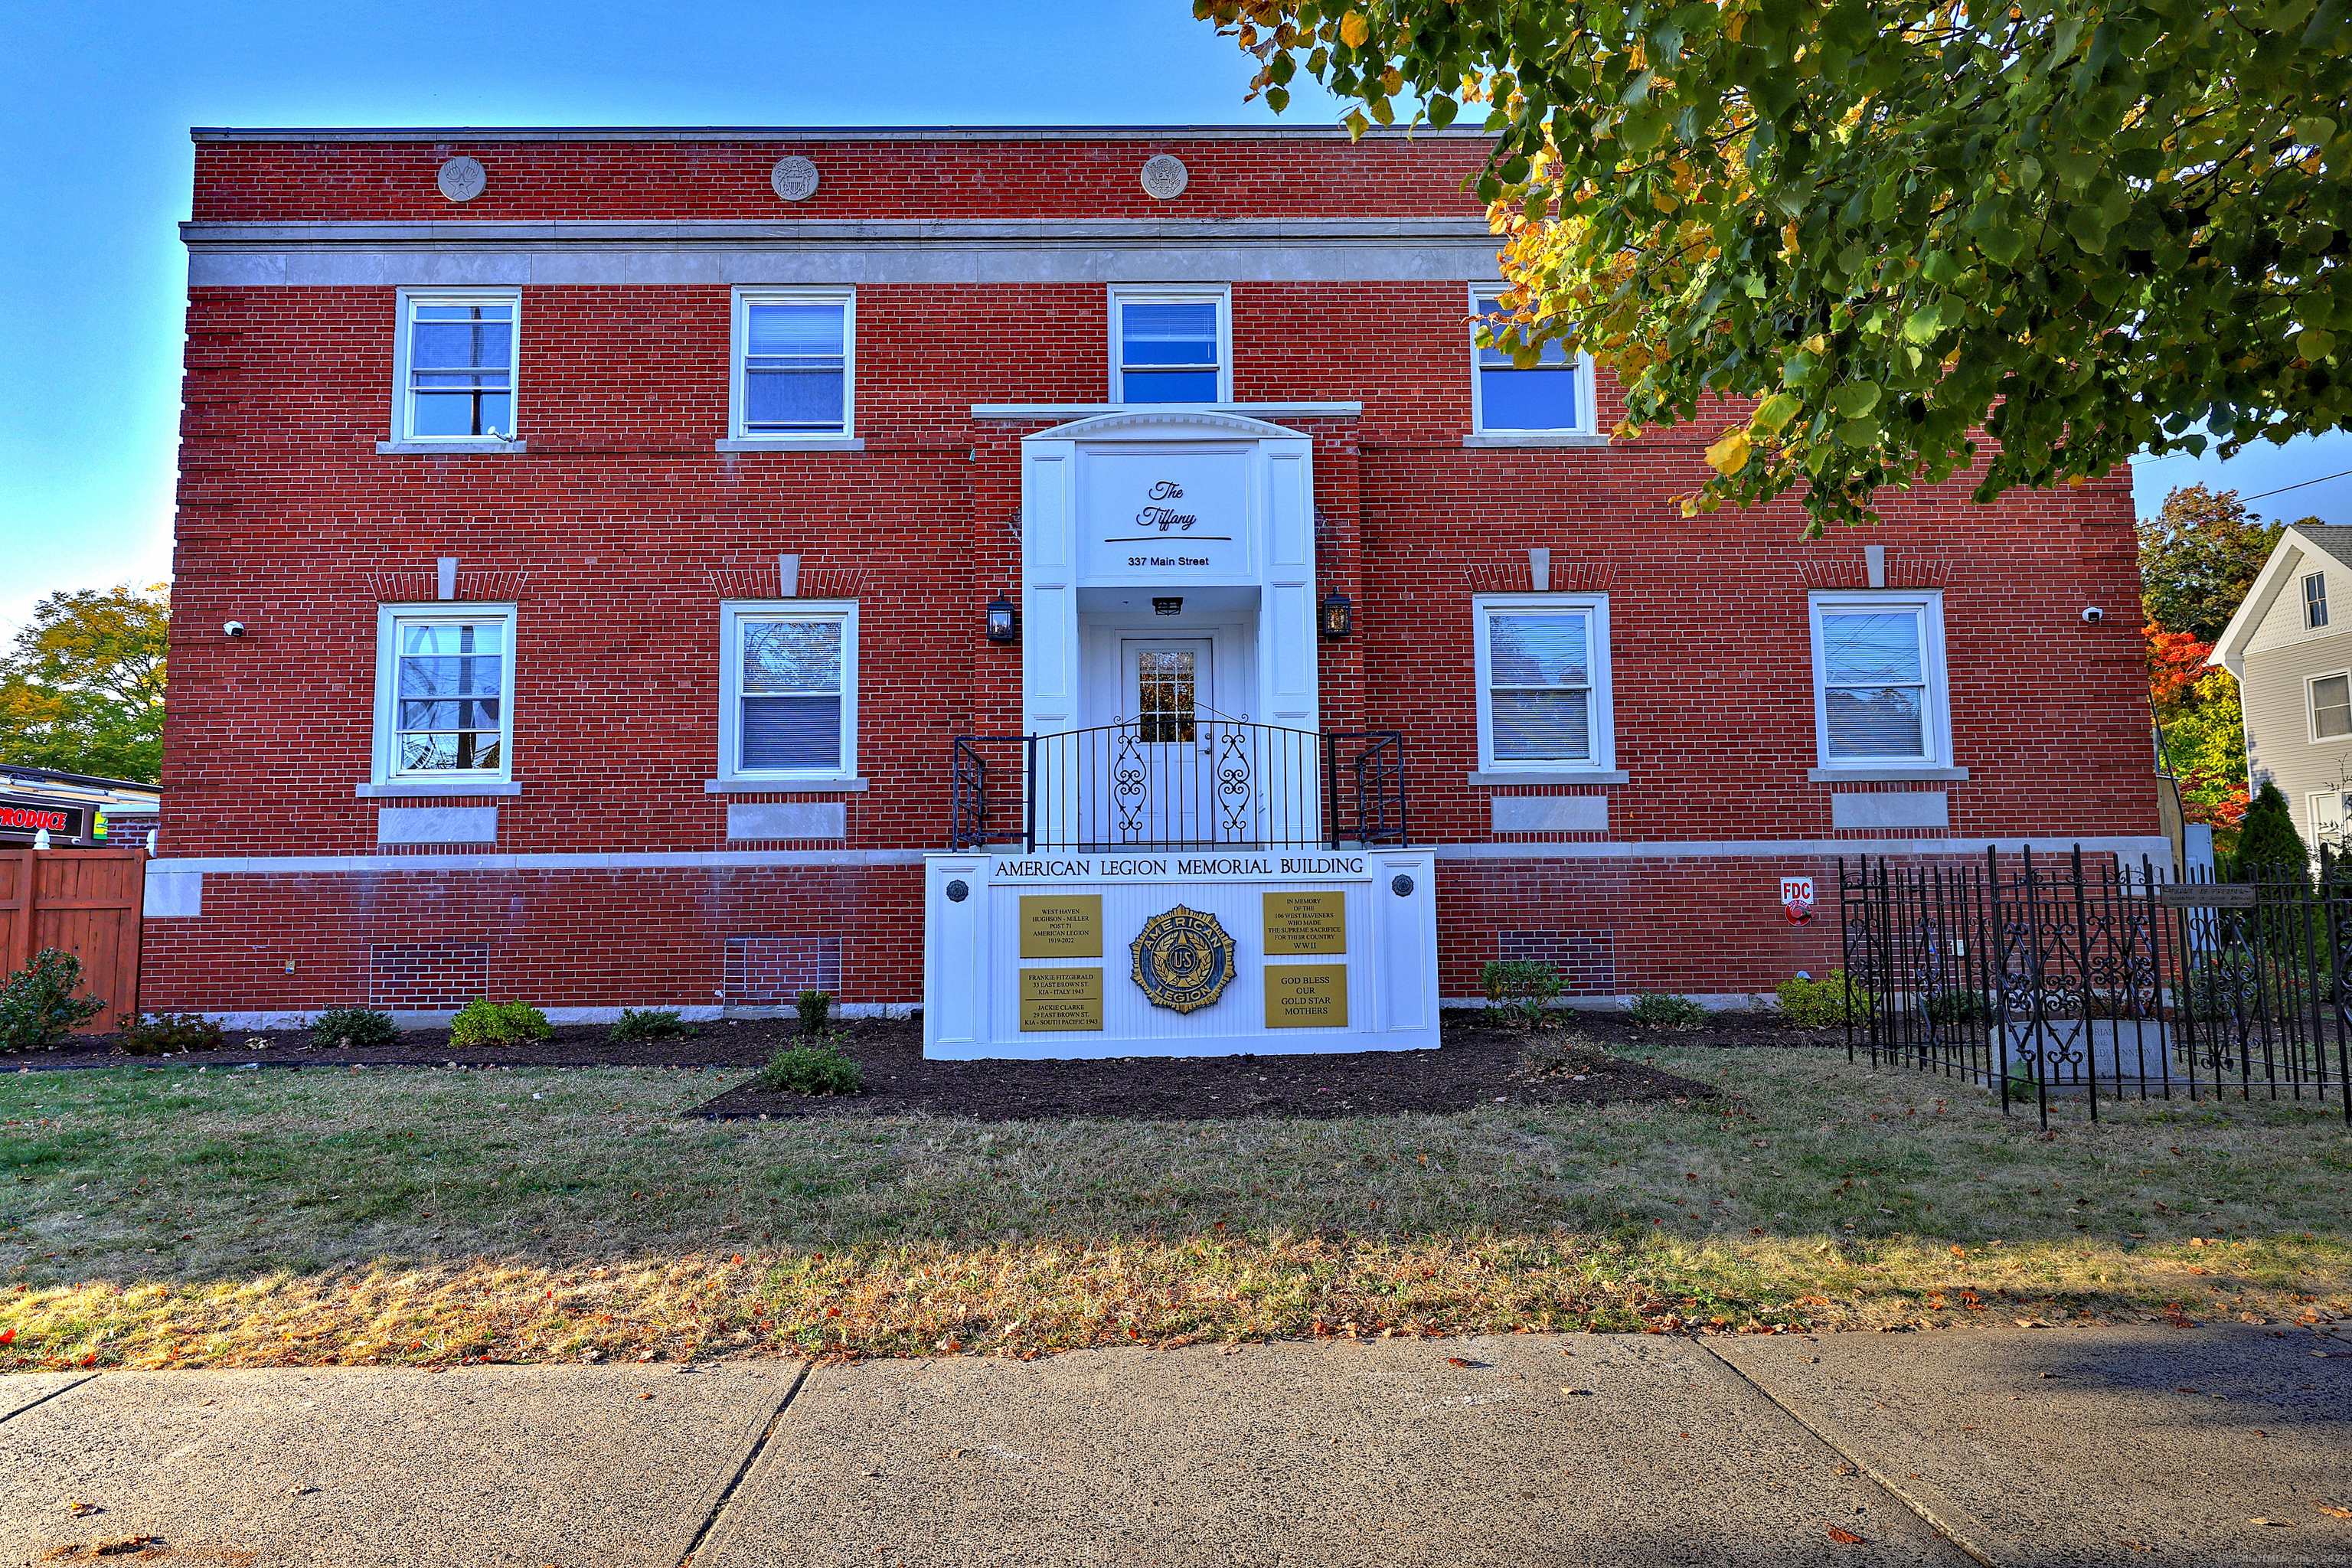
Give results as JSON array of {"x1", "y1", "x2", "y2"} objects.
[{"x1": 727, "y1": 289, "x2": 858, "y2": 444}]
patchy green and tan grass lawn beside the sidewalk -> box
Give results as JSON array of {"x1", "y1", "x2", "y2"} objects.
[{"x1": 0, "y1": 1046, "x2": 2352, "y2": 1368}]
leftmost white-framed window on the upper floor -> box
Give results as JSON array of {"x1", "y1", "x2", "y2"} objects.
[{"x1": 393, "y1": 289, "x2": 522, "y2": 442}]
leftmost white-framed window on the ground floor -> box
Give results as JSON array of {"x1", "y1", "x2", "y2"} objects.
[{"x1": 377, "y1": 604, "x2": 515, "y2": 782}]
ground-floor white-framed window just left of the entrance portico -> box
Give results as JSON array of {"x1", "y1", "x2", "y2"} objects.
[{"x1": 720, "y1": 599, "x2": 858, "y2": 780}]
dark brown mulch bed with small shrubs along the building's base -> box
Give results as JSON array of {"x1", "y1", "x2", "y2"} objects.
[{"x1": 0, "y1": 1011, "x2": 1841, "y2": 1122}]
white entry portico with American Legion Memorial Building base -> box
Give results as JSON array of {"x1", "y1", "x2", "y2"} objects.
[{"x1": 924, "y1": 409, "x2": 1437, "y2": 1058}]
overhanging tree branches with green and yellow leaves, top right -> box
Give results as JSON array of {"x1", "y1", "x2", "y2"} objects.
[{"x1": 1195, "y1": 0, "x2": 2352, "y2": 531}]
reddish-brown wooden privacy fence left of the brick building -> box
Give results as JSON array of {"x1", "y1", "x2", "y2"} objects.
[{"x1": 0, "y1": 848, "x2": 145, "y2": 1034}]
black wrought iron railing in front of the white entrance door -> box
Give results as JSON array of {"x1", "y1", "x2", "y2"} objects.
[{"x1": 948, "y1": 714, "x2": 1411, "y2": 851}]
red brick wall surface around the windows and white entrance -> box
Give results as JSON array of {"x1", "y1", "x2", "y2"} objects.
[{"x1": 149, "y1": 139, "x2": 2157, "y2": 1011}]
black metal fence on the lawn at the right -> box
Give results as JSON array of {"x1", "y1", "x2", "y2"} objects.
[{"x1": 1837, "y1": 848, "x2": 2352, "y2": 1124}]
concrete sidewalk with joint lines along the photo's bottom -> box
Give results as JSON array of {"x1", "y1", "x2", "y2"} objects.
[{"x1": 0, "y1": 1328, "x2": 2352, "y2": 1568}]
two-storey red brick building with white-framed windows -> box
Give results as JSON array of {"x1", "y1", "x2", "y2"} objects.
[{"x1": 145, "y1": 129, "x2": 2168, "y2": 1015}]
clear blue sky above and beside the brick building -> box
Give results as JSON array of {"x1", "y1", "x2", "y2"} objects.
[{"x1": 0, "y1": 0, "x2": 2352, "y2": 632}]
